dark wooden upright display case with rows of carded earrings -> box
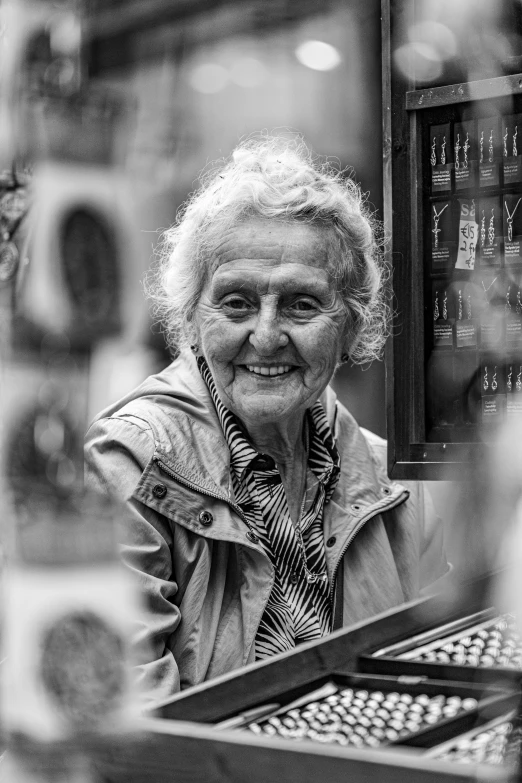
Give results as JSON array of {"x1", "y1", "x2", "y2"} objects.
[{"x1": 383, "y1": 0, "x2": 522, "y2": 479}]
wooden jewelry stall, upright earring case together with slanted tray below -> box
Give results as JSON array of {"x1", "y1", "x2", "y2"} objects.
[{"x1": 87, "y1": 0, "x2": 522, "y2": 783}]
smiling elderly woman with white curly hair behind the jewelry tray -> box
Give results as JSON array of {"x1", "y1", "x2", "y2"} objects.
[{"x1": 87, "y1": 138, "x2": 447, "y2": 698}]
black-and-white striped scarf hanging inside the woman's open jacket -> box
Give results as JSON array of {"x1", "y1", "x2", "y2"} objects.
[{"x1": 198, "y1": 357, "x2": 340, "y2": 660}]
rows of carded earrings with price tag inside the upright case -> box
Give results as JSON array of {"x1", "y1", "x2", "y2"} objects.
[{"x1": 418, "y1": 105, "x2": 522, "y2": 442}]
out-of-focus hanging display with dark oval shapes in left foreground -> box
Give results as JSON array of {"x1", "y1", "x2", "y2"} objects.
[{"x1": 0, "y1": 0, "x2": 152, "y2": 748}]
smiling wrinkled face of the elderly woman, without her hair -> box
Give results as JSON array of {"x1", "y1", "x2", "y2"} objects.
[{"x1": 195, "y1": 218, "x2": 346, "y2": 428}]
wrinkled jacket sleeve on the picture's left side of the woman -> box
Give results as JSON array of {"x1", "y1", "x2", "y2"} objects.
[{"x1": 85, "y1": 417, "x2": 181, "y2": 704}]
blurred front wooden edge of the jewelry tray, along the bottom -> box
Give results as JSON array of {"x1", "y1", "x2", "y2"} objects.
[{"x1": 91, "y1": 720, "x2": 508, "y2": 783}]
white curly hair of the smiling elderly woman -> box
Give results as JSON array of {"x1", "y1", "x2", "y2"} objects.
[{"x1": 146, "y1": 135, "x2": 389, "y2": 364}]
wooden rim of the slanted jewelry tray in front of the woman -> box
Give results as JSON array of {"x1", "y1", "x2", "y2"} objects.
[{"x1": 89, "y1": 576, "x2": 518, "y2": 783}]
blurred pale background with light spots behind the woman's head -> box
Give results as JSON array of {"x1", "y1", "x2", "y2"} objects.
[{"x1": 82, "y1": 0, "x2": 386, "y2": 436}]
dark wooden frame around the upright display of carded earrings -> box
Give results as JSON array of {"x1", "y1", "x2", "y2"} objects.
[{"x1": 383, "y1": 0, "x2": 522, "y2": 480}]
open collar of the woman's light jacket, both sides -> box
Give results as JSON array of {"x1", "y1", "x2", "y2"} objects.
[{"x1": 100, "y1": 352, "x2": 404, "y2": 517}]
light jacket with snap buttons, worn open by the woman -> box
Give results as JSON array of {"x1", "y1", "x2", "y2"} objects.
[{"x1": 86, "y1": 355, "x2": 447, "y2": 700}]
